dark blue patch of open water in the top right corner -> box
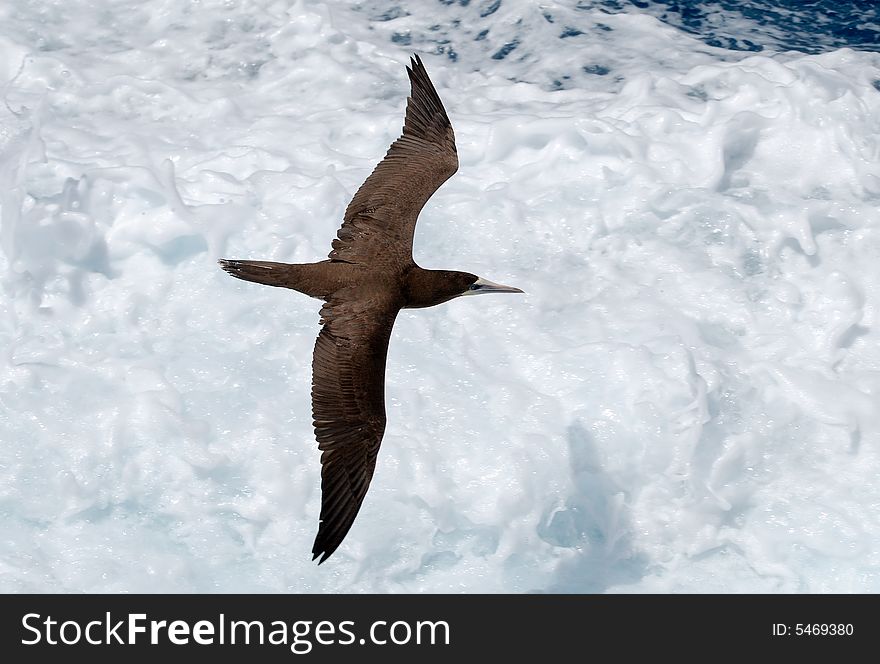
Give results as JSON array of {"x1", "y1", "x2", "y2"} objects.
[{"x1": 592, "y1": 0, "x2": 880, "y2": 53}]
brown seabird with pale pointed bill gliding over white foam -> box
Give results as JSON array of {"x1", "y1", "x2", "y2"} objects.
[{"x1": 220, "y1": 56, "x2": 523, "y2": 564}]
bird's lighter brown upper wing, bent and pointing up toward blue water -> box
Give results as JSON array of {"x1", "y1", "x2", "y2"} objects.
[{"x1": 330, "y1": 56, "x2": 458, "y2": 265}]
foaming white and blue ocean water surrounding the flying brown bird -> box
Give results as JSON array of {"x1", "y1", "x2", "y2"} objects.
[{"x1": 0, "y1": 0, "x2": 880, "y2": 593}]
